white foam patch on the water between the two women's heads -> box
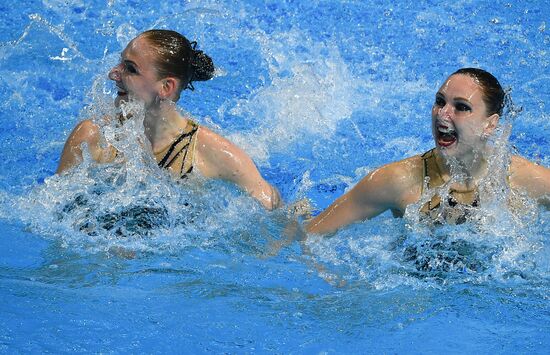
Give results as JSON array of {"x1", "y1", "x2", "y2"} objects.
[{"x1": 222, "y1": 30, "x2": 360, "y2": 161}]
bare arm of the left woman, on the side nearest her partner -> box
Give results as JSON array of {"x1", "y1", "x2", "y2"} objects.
[{"x1": 195, "y1": 127, "x2": 281, "y2": 210}]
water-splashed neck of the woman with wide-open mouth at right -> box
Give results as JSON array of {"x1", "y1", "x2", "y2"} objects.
[{"x1": 435, "y1": 149, "x2": 494, "y2": 191}]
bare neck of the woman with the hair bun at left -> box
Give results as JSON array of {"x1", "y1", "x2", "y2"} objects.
[{"x1": 143, "y1": 103, "x2": 192, "y2": 153}]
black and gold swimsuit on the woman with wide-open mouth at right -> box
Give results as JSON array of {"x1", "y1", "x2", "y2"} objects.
[{"x1": 420, "y1": 149, "x2": 479, "y2": 224}]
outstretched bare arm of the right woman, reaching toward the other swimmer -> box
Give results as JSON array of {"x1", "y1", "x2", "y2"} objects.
[{"x1": 306, "y1": 162, "x2": 414, "y2": 234}]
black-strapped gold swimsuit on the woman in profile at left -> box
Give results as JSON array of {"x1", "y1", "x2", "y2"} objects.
[{"x1": 155, "y1": 120, "x2": 199, "y2": 179}]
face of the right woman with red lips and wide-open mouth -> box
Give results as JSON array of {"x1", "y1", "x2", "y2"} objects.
[{"x1": 432, "y1": 74, "x2": 498, "y2": 156}]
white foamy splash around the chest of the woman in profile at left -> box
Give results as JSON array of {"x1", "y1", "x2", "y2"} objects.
[{"x1": 2, "y1": 78, "x2": 277, "y2": 256}]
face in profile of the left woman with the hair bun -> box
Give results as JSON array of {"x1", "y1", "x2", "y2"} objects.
[{"x1": 109, "y1": 37, "x2": 162, "y2": 107}]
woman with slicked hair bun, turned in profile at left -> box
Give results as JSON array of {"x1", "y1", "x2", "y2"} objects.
[{"x1": 57, "y1": 30, "x2": 280, "y2": 209}]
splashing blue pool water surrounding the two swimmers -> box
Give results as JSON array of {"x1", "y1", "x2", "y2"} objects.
[{"x1": 0, "y1": 0, "x2": 550, "y2": 353}]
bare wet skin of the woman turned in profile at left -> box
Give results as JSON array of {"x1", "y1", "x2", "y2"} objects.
[{"x1": 57, "y1": 32, "x2": 281, "y2": 209}]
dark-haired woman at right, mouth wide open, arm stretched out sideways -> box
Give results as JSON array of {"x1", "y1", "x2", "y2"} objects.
[{"x1": 306, "y1": 68, "x2": 550, "y2": 234}]
